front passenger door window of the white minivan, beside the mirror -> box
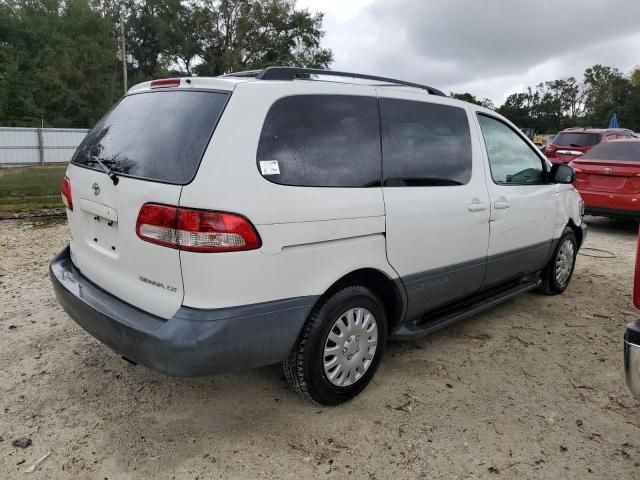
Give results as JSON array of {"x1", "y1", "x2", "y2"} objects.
[{"x1": 478, "y1": 114, "x2": 545, "y2": 184}]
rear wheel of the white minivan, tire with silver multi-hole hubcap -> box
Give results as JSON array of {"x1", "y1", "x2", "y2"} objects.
[{"x1": 283, "y1": 285, "x2": 387, "y2": 406}]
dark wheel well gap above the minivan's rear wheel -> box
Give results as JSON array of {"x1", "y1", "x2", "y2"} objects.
[{"x1": 317, "y1": 268, "x2": 404, "y2": 327}]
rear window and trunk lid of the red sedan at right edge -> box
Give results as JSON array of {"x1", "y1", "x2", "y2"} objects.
[{"x1": 571, "y1": 141, "x2": 640, "y2": 194}]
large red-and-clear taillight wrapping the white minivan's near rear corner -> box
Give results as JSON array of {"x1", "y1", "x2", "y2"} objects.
[{"x1": 136, "y1": 203, "x2": 260, "y2": 252}]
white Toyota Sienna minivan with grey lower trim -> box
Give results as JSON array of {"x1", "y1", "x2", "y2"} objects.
[{"x1": 50, "y1": 67, "x2": 586, "y2": 405}]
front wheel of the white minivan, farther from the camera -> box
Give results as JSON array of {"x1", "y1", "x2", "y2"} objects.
[{"x1": 540, "y1": 227, "x2": 578, "y2": 295}]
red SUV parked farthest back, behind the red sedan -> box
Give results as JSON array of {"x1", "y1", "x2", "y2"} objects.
[{"x1": 544, "y1": 128, "x2": 635, "y2": 163}]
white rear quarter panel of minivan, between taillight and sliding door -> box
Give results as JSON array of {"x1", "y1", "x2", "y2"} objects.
[{"x1": 180, "y1": 81, "x2": 397, "y2": 308}]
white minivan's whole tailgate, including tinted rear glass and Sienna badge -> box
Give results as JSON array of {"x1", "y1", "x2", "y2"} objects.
[{"x1": 67, "y1": 89, "x2": 229, "y2": 318}]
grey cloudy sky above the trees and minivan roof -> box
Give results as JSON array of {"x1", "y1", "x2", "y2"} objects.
[{"x1": 297, "y1": 0, "x2": 640, "y2": 105}]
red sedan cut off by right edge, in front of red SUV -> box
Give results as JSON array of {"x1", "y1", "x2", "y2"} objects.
[{"x1": 569, "y1": 139, "x2": 640, "y2": 219}]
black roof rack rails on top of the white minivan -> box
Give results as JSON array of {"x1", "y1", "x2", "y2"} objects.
[{"x1": 223, "y1": 67, "x2": 446, "y2": 97}]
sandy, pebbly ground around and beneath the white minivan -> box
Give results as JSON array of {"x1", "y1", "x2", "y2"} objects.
[{"x1": 0, "y1": 218, "x2": 640, "y2": 479}]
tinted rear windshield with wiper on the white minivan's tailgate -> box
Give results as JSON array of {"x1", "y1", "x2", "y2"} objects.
[{"x1": 71, "y1": 90, "x2": 229, "y2": 185}]
